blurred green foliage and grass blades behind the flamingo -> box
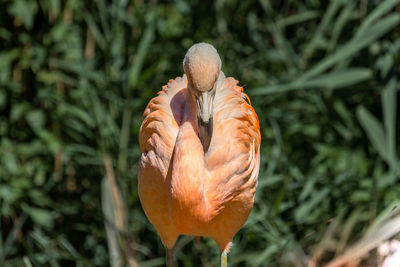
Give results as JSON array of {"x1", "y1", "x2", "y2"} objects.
[{"x1": 0, "y1": 0, "x2": 400, "y2": 267}]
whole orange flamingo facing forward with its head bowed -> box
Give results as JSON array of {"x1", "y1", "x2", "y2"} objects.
[{"x1": 138, "y1": 43, "x2": 261, "y2": 266}]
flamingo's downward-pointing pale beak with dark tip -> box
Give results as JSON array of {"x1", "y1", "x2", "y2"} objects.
[{"x1": 195, "y1": 88, "x2": 215, "y2": 153}]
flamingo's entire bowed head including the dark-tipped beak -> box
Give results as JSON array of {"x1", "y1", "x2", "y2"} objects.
[{"x1": 183, "y1": 43, "x2": 221, "y2": 152}]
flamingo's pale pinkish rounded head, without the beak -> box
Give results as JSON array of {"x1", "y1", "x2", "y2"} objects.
[{"x1": 183, "y1": 43, "x2": 221, "y2": 92}]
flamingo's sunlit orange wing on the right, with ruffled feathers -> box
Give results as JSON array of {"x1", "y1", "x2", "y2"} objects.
[{"x1": 206, "y1": 78, "x2": 261, "y2": 214}]
